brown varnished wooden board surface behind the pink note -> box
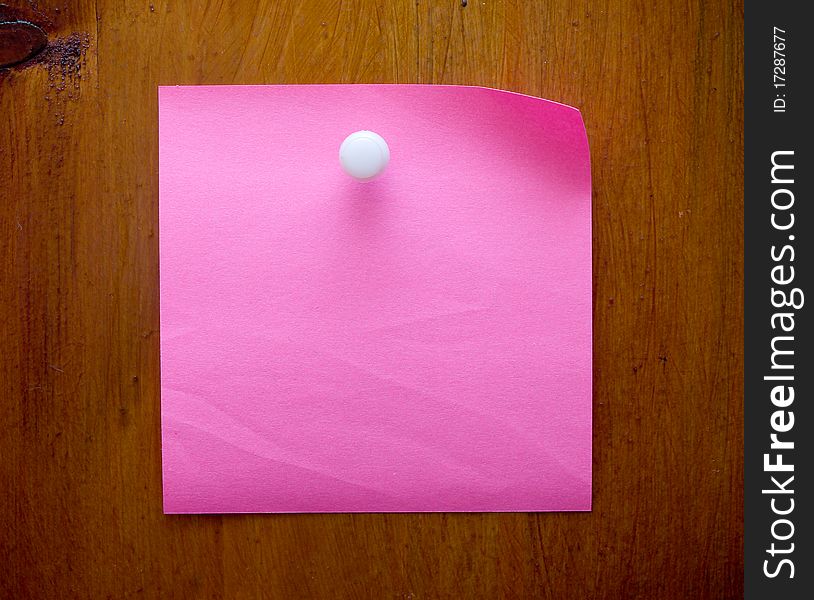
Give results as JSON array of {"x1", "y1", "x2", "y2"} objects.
[{"x1": 0, "y1": 0, "x2": 743, "y2": 599}]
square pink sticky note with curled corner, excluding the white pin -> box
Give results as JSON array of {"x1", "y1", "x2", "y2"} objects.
[{"x1": 159, "y1": 85, "x2": 591, "y2": 513}]
